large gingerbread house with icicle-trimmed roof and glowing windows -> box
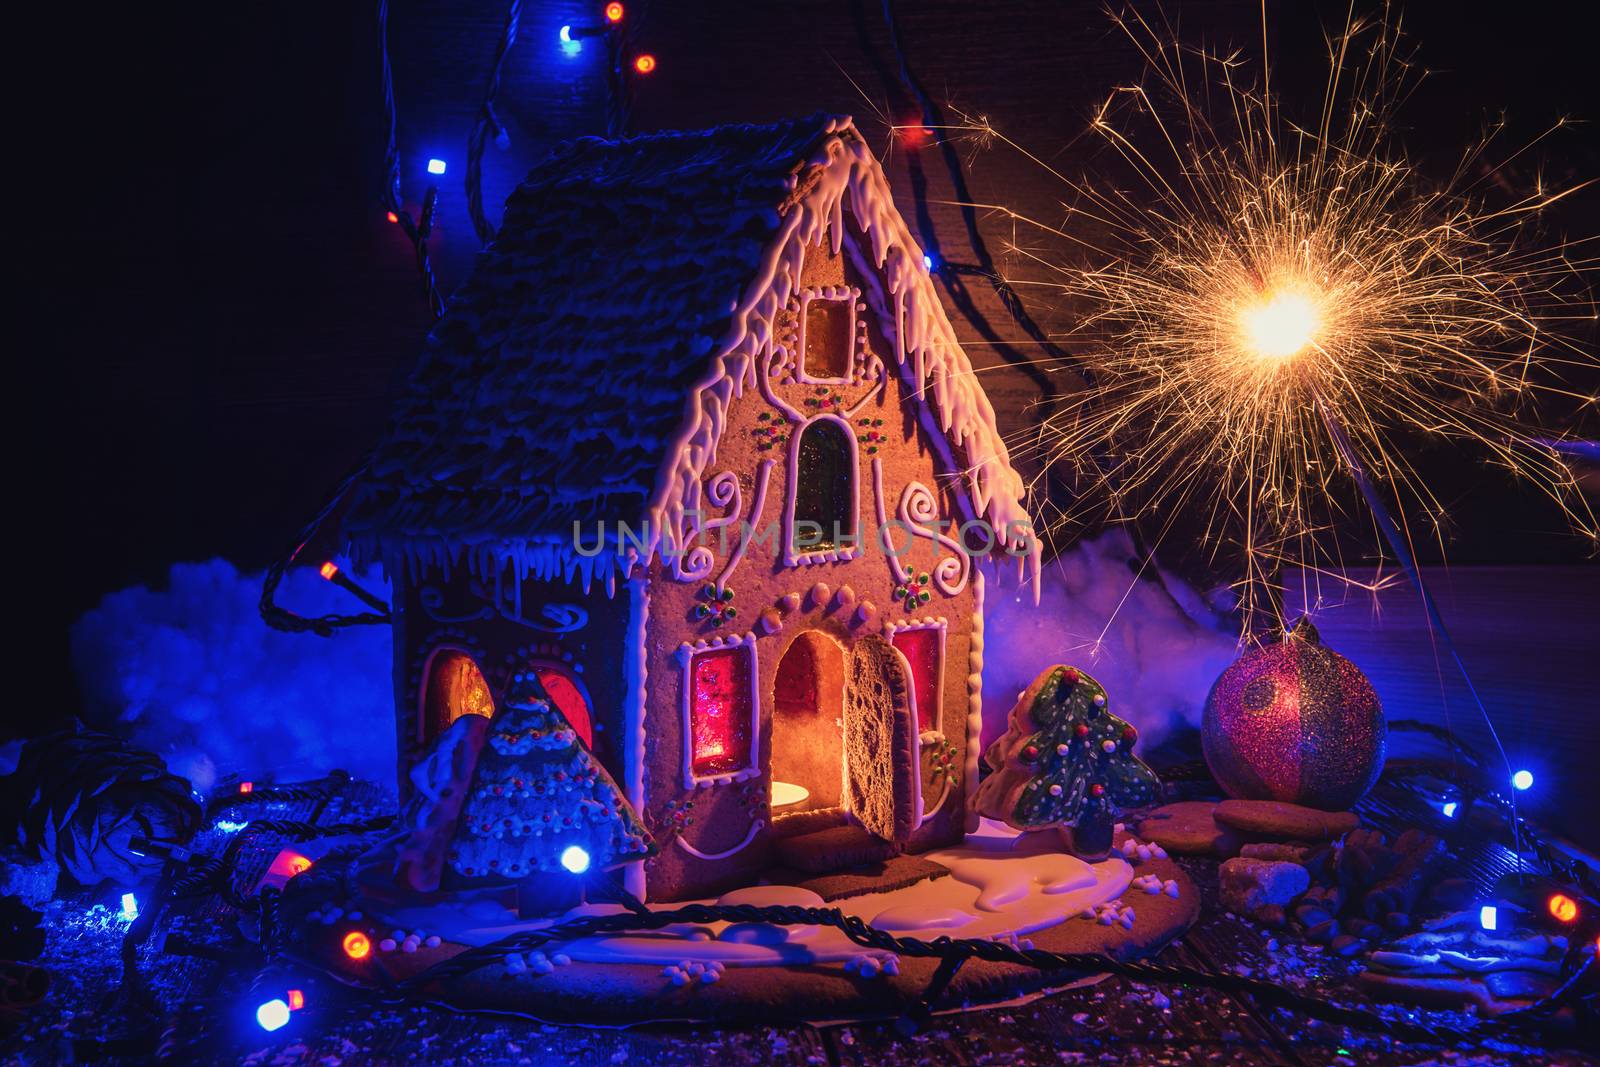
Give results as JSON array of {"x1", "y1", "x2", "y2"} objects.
[{"x1": 341, "y1": 117, "x2": 1037, "y2": 901}]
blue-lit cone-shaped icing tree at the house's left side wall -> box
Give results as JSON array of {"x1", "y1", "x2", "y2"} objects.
[{"x1": 446, "y1": 672, "x2": 653, "y2": 881}]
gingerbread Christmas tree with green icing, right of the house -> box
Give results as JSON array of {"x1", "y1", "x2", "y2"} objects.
[{"x1": 976, "y1": 665, "x2": 1160, "y2": 853}]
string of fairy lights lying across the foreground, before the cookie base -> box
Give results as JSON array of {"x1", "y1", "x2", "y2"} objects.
[{"x1": 109, "y1": 720, "x2": 1600, "y2": 1046}]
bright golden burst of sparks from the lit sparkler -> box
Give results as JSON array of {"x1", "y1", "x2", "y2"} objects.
[{"x1": 981, "y1": 4, "x2": 1600, "y2": 632}]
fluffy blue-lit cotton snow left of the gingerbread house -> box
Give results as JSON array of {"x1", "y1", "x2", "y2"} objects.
[{"x1": 72, "y1": 560, "x2": 395, "y2": 792}]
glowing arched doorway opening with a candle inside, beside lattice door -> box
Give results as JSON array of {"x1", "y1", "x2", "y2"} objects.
[{"x1": 771, "y1": 630, "x2": 845, "y2": 814}]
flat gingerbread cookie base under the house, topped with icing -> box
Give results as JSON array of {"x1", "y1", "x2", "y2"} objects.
[{"x1": 285, "y1": 821, "x2": 1200, "y2": 1025}]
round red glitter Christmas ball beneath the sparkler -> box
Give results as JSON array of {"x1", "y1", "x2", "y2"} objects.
[{"x1": 1200, "y1": 617, "x2": 1387, "y2": 811}]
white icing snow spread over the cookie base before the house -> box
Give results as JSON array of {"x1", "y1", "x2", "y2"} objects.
[{"x1": 377, "y1": 819, "x2": 1133, "y2": 973}]
